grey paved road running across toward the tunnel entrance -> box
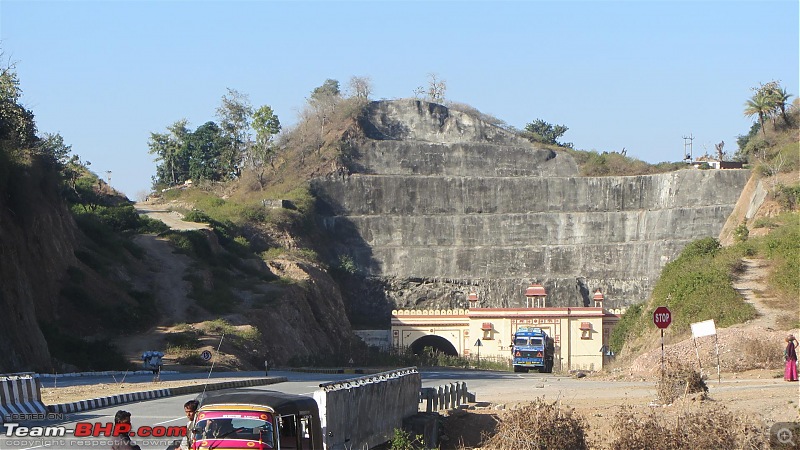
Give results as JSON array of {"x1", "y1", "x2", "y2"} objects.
[{"x1": 0, "y1": 370, "x2": 653, "y2": 450}]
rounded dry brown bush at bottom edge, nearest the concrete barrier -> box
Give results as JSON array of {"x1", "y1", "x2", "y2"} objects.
[{"x1": 484, "y1": 399, "x2": 589, "y2": 450}]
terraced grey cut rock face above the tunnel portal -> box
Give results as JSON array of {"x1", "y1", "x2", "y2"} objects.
[{"x1": 313, "y1": 100, "x2": 749, "y2": 317}]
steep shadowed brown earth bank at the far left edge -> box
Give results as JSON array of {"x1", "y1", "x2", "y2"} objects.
[{"x1": 0, "y1": 165, "x2": 77, "y2": 372}]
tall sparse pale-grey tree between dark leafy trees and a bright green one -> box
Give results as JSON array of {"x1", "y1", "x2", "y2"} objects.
[{"x1": 217, "y1": 88, "x2": 253, "y2": 178}]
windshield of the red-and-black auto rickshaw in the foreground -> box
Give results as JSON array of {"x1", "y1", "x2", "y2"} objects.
[{"x1": 193, "y1": 411, "x2": 274, "y2": 448}]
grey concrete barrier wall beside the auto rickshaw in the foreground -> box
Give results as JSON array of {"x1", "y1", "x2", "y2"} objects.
[{"x1": 314, "y1": 367, "x2": 422, "y2": 450}]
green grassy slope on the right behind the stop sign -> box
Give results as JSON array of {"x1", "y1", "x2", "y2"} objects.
[{"x1": 611, "y1": 109, "x2": 800, "y2": 356}]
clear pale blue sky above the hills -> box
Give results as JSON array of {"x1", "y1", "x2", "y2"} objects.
[{"x1": 0, "y1": 0, "x2": 800, "y2": 199}]
